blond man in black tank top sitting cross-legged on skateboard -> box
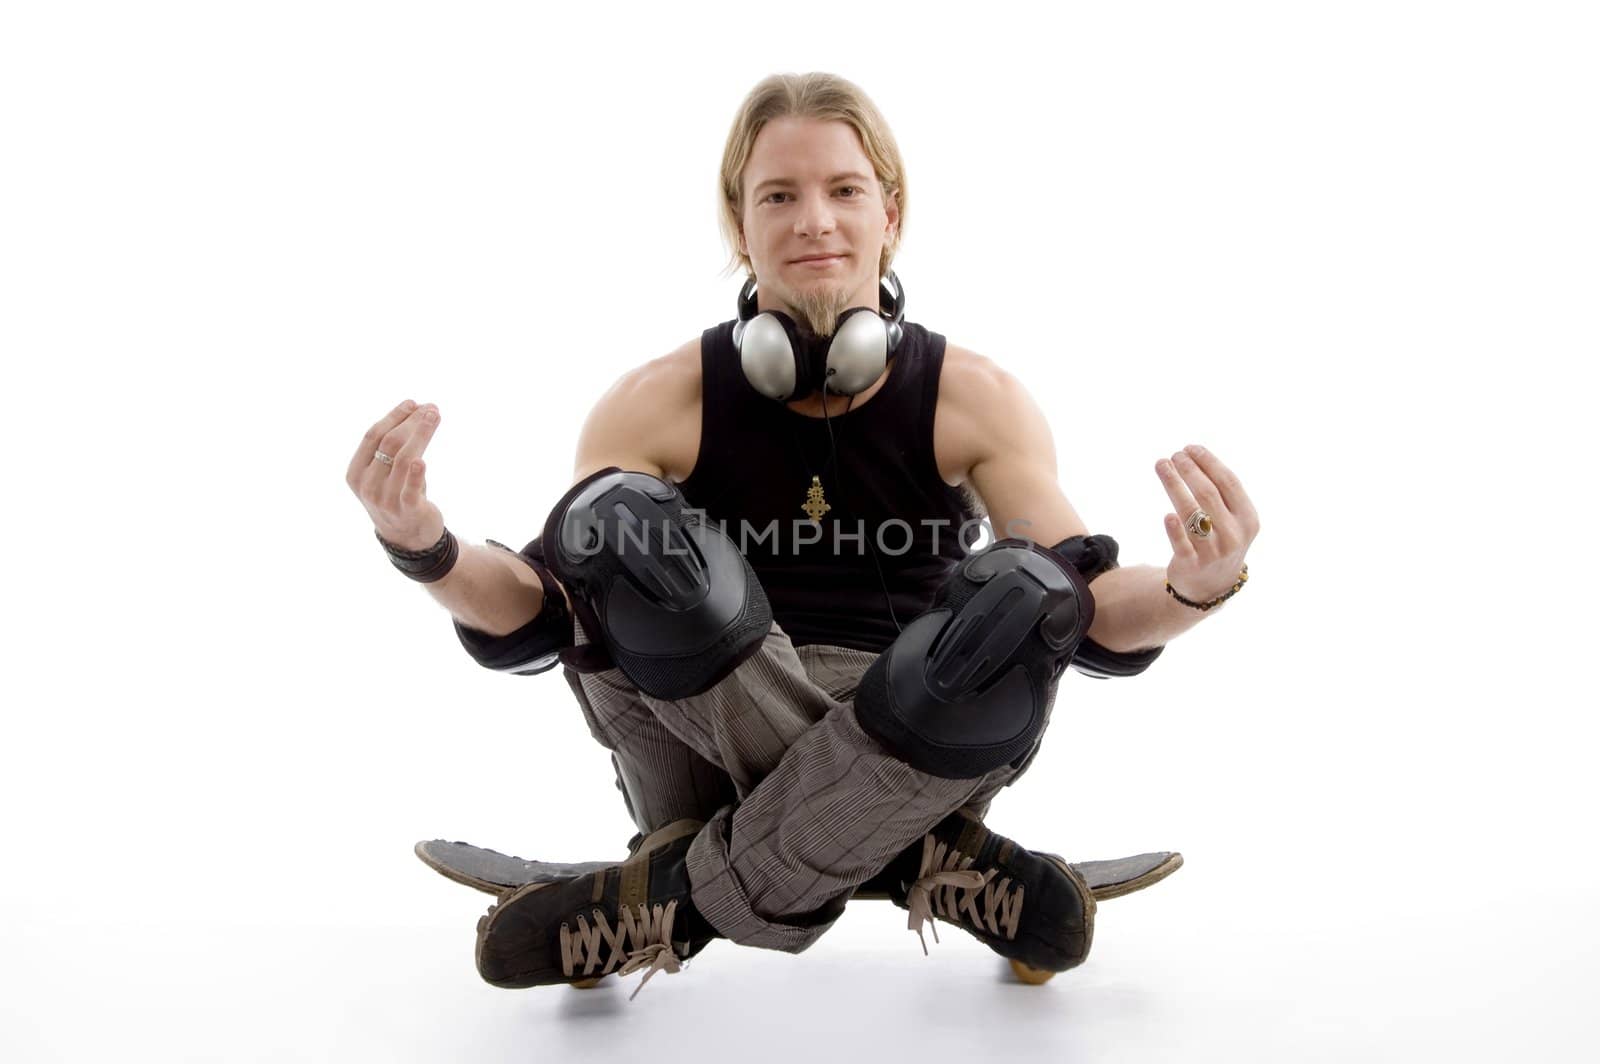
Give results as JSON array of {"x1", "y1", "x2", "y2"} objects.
[{"x1": 347, "y1": 75, "x2": 1259, "y2": 986}]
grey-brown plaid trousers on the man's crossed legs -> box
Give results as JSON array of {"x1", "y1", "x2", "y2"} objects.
[{"x1": 563, "y1": 622, "x2": 1056, "y2": 954}]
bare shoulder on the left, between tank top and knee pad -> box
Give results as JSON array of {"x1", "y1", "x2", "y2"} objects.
[{"x1": 573, "y1": 336, "x2": 701, "y2": 482}]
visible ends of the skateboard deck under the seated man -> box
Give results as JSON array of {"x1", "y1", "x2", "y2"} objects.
[{"x1": 416, "y1": 838, "x2": 1184, "y2": 901}]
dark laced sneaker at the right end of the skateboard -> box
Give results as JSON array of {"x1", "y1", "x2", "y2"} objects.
[{"x1": 875, "y1": 811, "x2": 1094, "y2": 982}]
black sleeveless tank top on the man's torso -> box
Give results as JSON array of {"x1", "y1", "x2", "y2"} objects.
[{"x1": 678, "y1": 322, "x2": 984, "y2": 653}]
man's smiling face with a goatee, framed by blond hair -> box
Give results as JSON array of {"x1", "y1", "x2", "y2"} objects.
[{"x1": 741, "y1": 118, "x2": 899, "y2": 326}]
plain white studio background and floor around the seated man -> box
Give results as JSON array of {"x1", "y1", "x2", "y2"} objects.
[{"x1": 0, "y1": 2, "x2": 1600, "y2": 1061}]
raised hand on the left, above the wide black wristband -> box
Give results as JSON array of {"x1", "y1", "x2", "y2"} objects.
[{"x1": 344, "y1": 400, "x2": 445, "y2": 550}]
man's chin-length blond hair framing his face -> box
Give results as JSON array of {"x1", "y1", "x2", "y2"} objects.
[{"x1": 720, "y1": 74, "x2": 906, "y2": 277}]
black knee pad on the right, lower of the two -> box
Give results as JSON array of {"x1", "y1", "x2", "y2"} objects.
[{"x1": 856, "y1": 539, "x2": 1094, "y2": 779}]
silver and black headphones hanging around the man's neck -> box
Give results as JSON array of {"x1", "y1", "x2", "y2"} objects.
[{"x1": 733, "y1": 270, "x2": 906, "y2": 403}]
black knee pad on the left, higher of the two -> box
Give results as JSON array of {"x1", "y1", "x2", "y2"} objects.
[{"x1": 544, "y1": 467, "x2": 773, "y2": 699}]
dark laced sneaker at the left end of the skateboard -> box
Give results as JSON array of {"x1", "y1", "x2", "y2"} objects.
[{"x1": 477, "y1": 821, "x2": 722, "y2": 1000}]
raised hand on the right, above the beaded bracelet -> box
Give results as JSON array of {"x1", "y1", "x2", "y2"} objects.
[{"x1": 1155, "y1": 445, "x2": 1261, "y2": 602}]
